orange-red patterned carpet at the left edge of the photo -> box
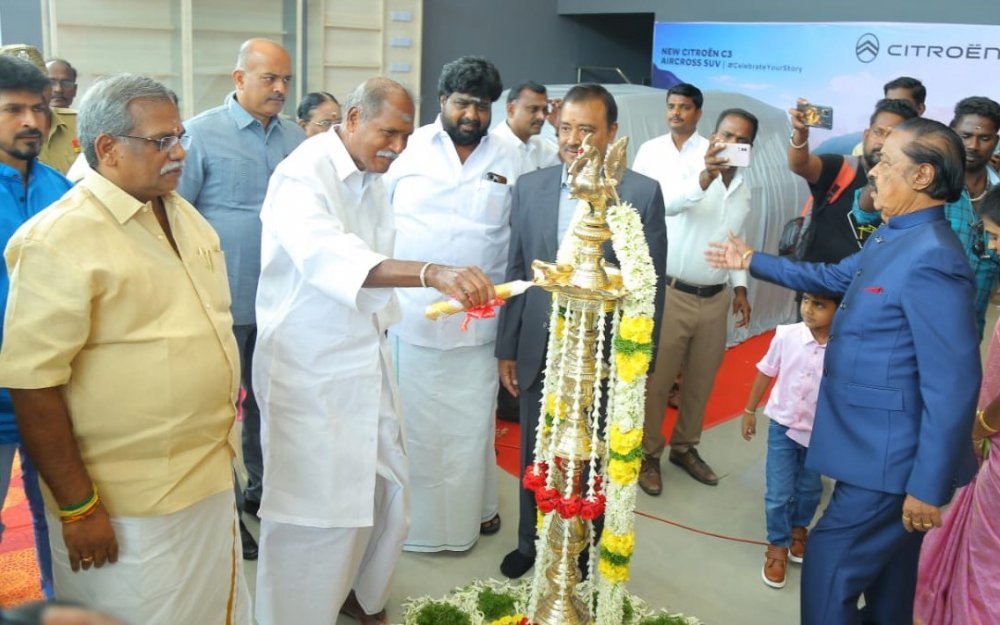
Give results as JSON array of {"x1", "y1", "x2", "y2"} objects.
[{"x1": 0, "y1": 457, "x2": 42, "y2": 607}]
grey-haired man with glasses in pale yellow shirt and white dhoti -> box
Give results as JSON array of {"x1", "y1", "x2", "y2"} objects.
[{"x1": 0, "y1": 75, "x2": 250, "y2": 625}]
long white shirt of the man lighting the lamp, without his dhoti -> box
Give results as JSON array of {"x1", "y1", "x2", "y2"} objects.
[{"x1": 253, "y1": 131, "x2": 406, "y2": 527}]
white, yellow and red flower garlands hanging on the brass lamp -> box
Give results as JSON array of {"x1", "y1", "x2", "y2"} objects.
[{"x1": 523, "y1": 196, "x2": 656, "y2": 625}]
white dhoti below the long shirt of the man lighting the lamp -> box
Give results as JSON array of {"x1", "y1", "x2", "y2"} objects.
[{"x1": 256, "y1": 360, "x2": 408, "y2": 625}]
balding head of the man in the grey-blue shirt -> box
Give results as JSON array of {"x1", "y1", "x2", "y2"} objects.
[{"x1": 233, "y1": 39, "x2": 292, "y2": 128}]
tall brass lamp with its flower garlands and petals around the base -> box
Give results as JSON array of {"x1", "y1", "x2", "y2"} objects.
[{"x1": 406, "y1": 138, "x2": 700, "y2": 625}]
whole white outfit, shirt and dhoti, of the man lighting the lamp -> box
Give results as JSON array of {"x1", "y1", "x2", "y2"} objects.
[{"x1": 253, "y1": 131, "x2": 409, "y2": 625}]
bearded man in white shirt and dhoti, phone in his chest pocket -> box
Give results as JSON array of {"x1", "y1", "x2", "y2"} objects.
[{"x1": 384, "y1": 56, "x2": 522, "y2": 552}]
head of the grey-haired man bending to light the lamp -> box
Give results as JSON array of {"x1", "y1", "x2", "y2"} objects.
[{"x1": 337, "y1": 78, "x2": 414, "y2": 174}]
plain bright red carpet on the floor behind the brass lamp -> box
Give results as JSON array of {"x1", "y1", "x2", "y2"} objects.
[{"x1": 496, "y1": 330, "x2": 774, "y2": 475}]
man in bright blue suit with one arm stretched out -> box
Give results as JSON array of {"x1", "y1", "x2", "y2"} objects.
[{"x1": 706, "y1": 117, "x2": 981, "y2": 625}]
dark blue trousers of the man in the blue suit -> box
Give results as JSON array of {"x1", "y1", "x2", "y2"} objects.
[{"x1": 802, "y1": 482, "x2": 924, "y2": 625}]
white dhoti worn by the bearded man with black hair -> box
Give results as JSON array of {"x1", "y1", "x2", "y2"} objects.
[{"x1": 392, "y1": 336, "x2": 499, "y2": 551}]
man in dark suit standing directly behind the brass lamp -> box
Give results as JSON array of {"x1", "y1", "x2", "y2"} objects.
[{"x1": 496, "y1": 84, "x2": 667, "y2": 578}]
